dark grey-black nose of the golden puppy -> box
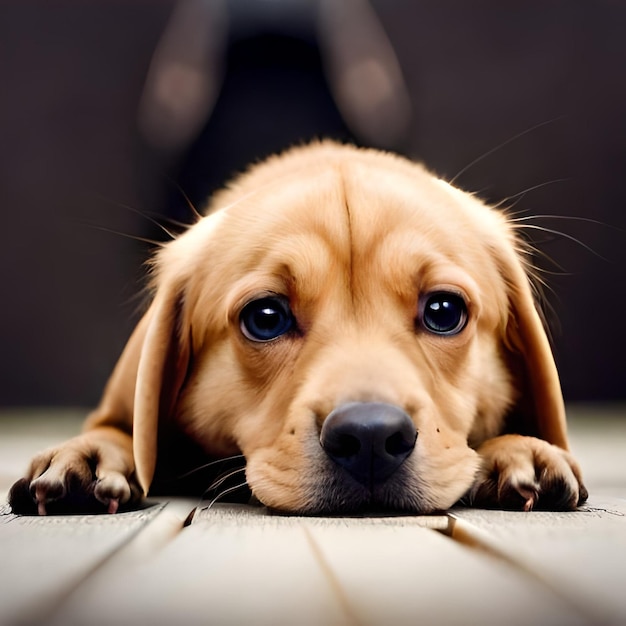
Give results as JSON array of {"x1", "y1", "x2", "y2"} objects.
[{"x1": 320, "y1": 402, "x2": 417, "y2": 486}]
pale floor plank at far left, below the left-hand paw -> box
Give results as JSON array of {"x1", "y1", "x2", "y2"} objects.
[{"x1": 0, "y1": 505, "x2": 163, "y2": 624}]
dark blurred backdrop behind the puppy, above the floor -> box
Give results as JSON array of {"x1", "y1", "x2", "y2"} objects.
[{"x1": 0, "y1": 0, "x2": 626, "y2": 406}]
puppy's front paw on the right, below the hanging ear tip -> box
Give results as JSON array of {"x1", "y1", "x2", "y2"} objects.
[{"x1": 464, "y1": 435, "x2": 588, "y2": 511}]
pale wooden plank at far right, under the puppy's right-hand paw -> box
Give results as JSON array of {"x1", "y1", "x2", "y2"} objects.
[{"x1": 450, "y1": 497, "x2": 626, "y2": 624}]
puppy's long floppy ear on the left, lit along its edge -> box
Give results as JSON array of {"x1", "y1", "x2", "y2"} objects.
[{"x1": 133, "y1": 284, "x2": 190, "y2": 494}]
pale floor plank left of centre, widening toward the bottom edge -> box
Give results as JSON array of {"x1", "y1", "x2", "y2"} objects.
[{"x1": 48, "y1": 505, "x2": 352, "y2": 626}]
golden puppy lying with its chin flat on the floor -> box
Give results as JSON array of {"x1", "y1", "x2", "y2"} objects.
[{"x1": 11, "y1": 142, "x2": 587, "y2": 514}]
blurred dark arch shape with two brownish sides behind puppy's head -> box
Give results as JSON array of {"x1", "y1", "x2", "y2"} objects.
[{"x1": 139, "y1": 0, "x2": 411, "y2": 219}]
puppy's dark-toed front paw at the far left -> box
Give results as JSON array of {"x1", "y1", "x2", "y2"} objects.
[{"x1": 9, "y1": 433, "x2": 142, "y2": 515}]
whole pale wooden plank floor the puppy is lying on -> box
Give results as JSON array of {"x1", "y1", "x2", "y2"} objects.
[{"x1": 0, "y1": 407, "x2": 626, "y2": 626}]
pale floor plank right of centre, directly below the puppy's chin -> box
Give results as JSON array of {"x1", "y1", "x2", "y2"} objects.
[{"x1": 307, "y1": 518, "x2": 589, "y2": 626}]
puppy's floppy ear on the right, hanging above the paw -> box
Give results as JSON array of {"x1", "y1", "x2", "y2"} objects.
[{"x1": 500, "y1": 243, "x2": 569, "y2": 450}]
